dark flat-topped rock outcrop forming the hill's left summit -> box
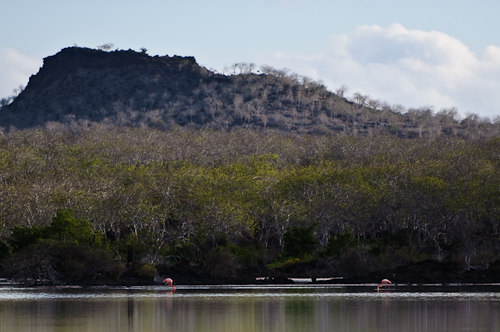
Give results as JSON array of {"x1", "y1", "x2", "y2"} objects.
[{"x1": 0, "y1": 47, "x2": 209, "y2": 128}]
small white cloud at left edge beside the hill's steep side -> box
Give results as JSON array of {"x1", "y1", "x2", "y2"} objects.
[{"x1": 0, "y1": 47, "x2": 41, "y2": 98}]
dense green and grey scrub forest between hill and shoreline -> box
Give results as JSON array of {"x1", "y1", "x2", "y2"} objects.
[{"x1": 0, "y1": 124, "x2": 500, "y2": 283}]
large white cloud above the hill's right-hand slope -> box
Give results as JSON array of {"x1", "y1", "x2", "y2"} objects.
[{"x1": 259, "y1": 24, "x2": 500, "y2": 117}]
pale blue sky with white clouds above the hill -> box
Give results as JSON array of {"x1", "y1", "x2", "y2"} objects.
[{"x1": 0, "y1": 0, "x2": 500, "y2": 120}]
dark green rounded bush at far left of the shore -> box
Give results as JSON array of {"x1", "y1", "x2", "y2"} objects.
[{"x1": 2, "y1": 209, "x2": 116, "y2": 284}]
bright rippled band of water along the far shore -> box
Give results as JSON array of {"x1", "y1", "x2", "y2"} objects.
[{"x1": 0, "y1": 284, "x2": 500, "y2": 302}]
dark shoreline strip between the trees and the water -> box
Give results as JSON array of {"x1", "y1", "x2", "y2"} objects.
[{"x1": 0, "y1": 260, "x2": 500, "y2": 287}]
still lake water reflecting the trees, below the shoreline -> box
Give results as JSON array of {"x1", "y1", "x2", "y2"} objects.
[{"x1": 0, "y1": 285, "x2": 500, "y2": 332}]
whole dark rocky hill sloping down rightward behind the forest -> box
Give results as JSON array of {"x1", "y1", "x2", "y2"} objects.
[{"x1": 0, "y1": 47, "x2": 499, "y2": 137}]
